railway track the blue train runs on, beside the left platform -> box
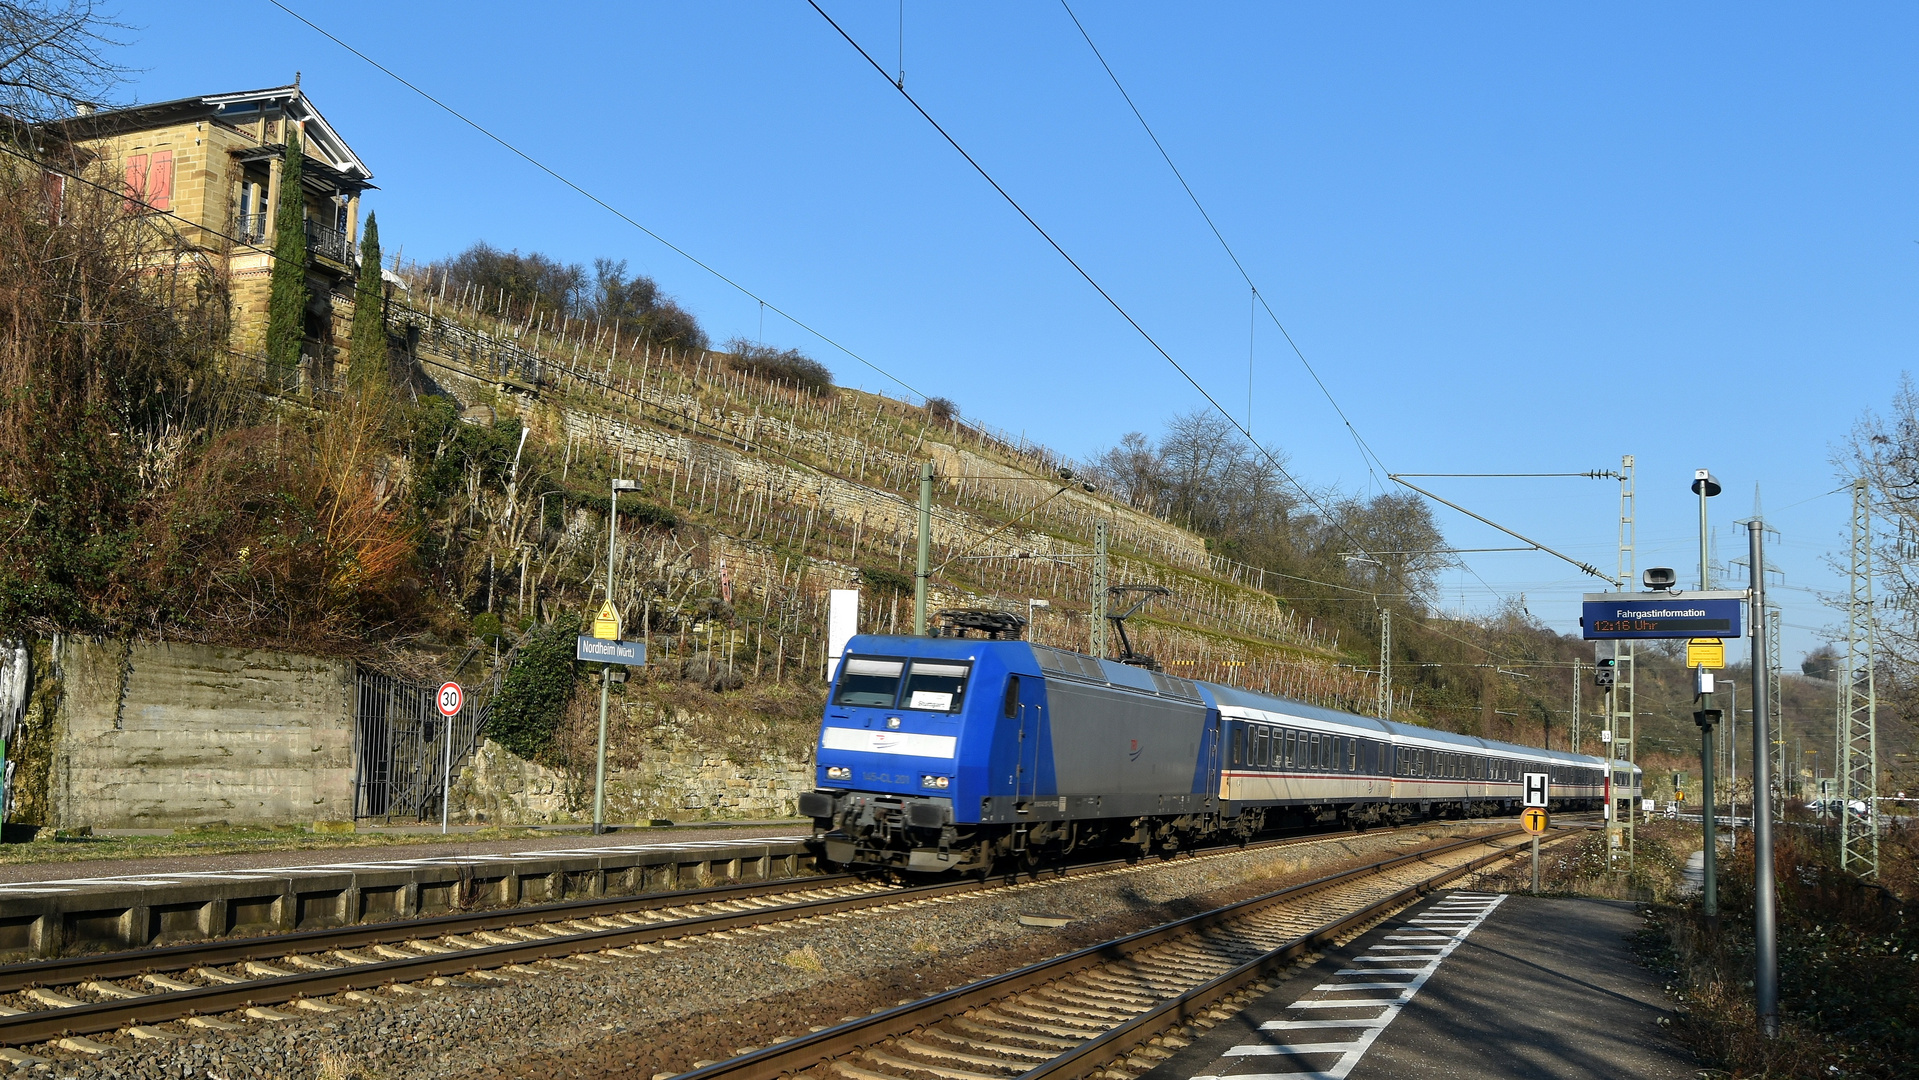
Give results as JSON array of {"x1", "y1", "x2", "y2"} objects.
[{"x1": 0, "y1": 825, "x2": 1496, "y2": 1049}]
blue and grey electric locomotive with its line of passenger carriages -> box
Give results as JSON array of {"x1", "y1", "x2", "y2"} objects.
[{"x1": 800, "y1": 635, "x2": 1639, "y2": 871}]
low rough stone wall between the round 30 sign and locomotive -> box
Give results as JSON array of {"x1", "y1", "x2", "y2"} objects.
[{"x1": 453, "y1": 739, "x2": 814, "y2": 825}]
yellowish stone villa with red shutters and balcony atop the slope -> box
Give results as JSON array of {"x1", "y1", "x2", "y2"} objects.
[{"x1": 50, "y1": 79, "x2": 372, "y2": 382}]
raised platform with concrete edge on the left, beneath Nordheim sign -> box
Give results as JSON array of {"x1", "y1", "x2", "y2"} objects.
[{"x1": 0, "y1": 831, "x2": 814, "y2": 963}]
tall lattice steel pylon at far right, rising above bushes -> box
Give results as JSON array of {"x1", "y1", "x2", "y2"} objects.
[{"x1": 1838, "y1": 476, "x2": 1879, "y2": 880}]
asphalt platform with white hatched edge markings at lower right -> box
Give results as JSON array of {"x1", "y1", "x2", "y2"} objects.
[{"x1": 1142, "y1": 890, "x2": 1698, "y2": 1080}]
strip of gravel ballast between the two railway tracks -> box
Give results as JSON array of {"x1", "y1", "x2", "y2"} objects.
[{"x1": 31, "y1": 823, "x2": 1491, "y2": 1080}]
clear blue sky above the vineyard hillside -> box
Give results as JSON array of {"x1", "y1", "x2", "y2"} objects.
[{"x1": 123, "y1": 0, "x2": 1919, "y2": 664}]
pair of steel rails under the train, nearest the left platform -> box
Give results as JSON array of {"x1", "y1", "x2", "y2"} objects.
[{"x1": 0, "y1": 823, "x2": 1504, "y2": 1045}]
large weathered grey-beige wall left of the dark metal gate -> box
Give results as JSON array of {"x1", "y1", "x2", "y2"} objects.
[{"x1": 44, "y1": 637, "x2": 353, "y2": 829}]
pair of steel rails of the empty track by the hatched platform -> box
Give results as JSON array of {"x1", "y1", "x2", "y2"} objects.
[{"x1": 674, "y1": 829, "x2": 1564, "y2": 1080}]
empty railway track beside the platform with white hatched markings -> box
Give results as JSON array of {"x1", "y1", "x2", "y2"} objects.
[{"x1": 675, "y1": 831, "x2": 1570, "y2": 1080}]
